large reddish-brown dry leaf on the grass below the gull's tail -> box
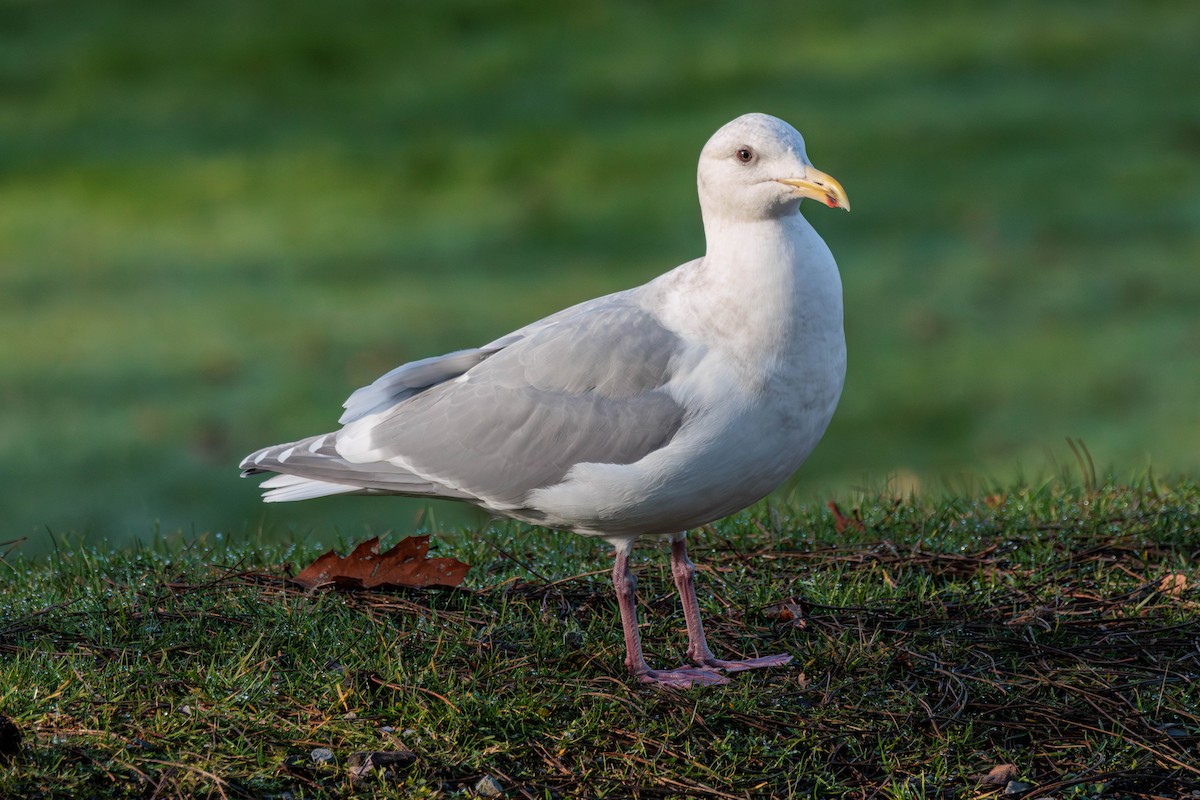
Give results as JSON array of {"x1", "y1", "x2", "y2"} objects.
[{"x1": 292, "y1": 536, "x2": 469, "y2": 589}]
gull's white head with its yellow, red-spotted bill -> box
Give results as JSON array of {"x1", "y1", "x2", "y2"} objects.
[{"x1": 696, "y1": 114, "x2": 850, "y2": 222}]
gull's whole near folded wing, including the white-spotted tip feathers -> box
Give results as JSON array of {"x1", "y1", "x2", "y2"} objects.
[{"x1": 242, "y1": 295, "x2": 684, "y2": 511}]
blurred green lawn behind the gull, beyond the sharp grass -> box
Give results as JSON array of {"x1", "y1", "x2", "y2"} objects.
[{"x1": 0, "y1": 0, "x2": 1200, "y2": 553}]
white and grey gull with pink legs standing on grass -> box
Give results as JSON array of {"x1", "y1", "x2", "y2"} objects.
[{"x1": 241, "y1": 114, "x2": 850, "y2": 687}]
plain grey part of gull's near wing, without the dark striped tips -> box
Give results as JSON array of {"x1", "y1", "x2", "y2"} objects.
[{"x1": 336, "y1": 295, "x2": 684, "y2": 509}]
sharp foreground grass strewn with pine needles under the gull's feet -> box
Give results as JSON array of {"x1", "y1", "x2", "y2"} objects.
[{"x1": 0, "y1": 480, "x2": 1200, "y2": 799}]
